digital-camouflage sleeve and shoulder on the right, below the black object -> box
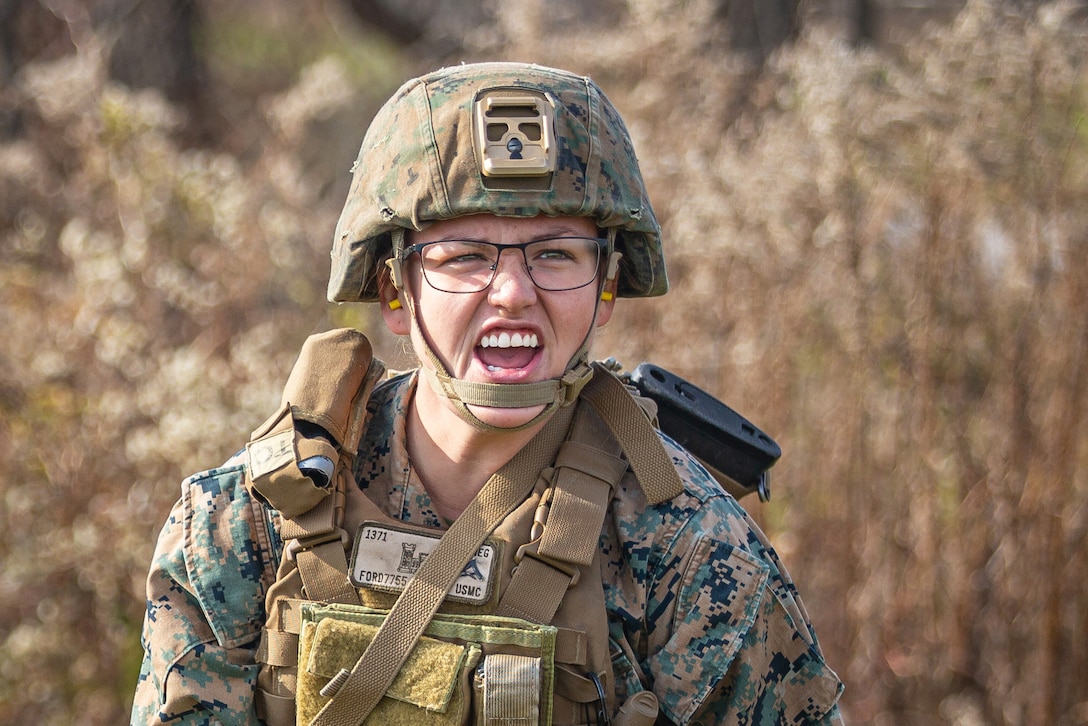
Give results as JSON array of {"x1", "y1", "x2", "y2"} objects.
[{"x1": 644, "y1": 435, "x2": 842, "y2": 724}]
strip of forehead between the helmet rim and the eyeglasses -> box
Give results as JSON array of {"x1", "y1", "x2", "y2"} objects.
[{"x1": 407, "y1": 214, "x2": 597, "y2": 244}]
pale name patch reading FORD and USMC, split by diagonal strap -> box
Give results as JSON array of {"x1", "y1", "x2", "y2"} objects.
[{"x1": 350, "y1": 521, "x2": 497, "y2": 605}]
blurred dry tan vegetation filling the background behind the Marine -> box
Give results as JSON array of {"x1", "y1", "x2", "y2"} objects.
[{"x1": 0, "y1": 0, "x2": 1088, "y2": 726}]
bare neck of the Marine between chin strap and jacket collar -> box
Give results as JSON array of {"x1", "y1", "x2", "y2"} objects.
[{"x1": 407, "y1": 381, "x2": 544, "y2": 519}]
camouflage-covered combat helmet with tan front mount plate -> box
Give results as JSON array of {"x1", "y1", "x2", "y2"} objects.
[{"x1": 329, "y1": 63, "x2": 668, "y2": 303}]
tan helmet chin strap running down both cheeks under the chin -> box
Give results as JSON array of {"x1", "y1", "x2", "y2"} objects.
[{"x1": 390, "y1": 229, "x2": 620, "y2": 432}]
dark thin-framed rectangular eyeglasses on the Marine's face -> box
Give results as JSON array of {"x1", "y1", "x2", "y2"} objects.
[{"x1": 404, "y1": 237, "x2": 608, "y2": 293}]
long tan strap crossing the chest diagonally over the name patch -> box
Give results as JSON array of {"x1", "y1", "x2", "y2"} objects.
[{"x1": 312, "y1": 408, "x2": 573, "y2": 726}]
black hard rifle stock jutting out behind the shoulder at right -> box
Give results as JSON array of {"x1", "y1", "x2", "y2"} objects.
[{"x1": 605, "y1": 358, "x2": 782, "y2": 502}]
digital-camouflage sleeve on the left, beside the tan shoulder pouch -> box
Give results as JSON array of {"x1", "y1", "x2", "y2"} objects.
[{"x1": 132, "y1": 467, "x2": 274, "y2": 726}]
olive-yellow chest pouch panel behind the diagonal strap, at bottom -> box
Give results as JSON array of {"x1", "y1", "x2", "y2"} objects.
[{"x1": 296, "y1": 603, "x2": 557, "y2": 726}]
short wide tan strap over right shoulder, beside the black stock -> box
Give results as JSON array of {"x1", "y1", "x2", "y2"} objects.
[{"x1": 582, "y1": 362, "x2": 683, "y2": 504}]
